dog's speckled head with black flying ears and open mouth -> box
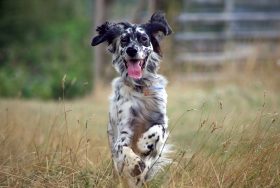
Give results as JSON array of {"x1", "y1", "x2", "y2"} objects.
[{"x1": 91, "y1": 12, "x2": 172, "y2": 81}]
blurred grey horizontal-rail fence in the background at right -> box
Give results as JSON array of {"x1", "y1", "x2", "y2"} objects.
[{"x1": 175, "y1": 0, "x2": 280, "y2": 75}]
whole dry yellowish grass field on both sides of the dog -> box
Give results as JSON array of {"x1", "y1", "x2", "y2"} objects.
[{"x1": 0, "y1": 73, "x2": 280, "y2": 188}]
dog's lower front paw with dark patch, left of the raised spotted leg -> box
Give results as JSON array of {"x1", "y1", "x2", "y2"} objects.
[{"x1": 123, "y1": 146, "x2": 146, "y2": 177}]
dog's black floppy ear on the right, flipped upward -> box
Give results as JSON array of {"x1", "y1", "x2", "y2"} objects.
[{"x1": 142, "y1": 12, "x2": 172, "y2": 55}]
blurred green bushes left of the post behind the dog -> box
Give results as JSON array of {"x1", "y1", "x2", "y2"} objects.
[{"x1": 0, "y1": 0, "x2": 92, "y2": 99}]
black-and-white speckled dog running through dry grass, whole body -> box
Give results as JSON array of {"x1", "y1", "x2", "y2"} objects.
[{"x1": 92, "y1": 12, "x2": 172, "y2": 187}]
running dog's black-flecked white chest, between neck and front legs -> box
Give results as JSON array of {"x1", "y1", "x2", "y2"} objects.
[{"x1": 110, "y1": 78, "x2": 166, "y2": 139}]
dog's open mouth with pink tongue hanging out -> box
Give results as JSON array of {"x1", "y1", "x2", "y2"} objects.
[{"x1": 125, "y1": 59, "x2": 145, "y2": 79}]
